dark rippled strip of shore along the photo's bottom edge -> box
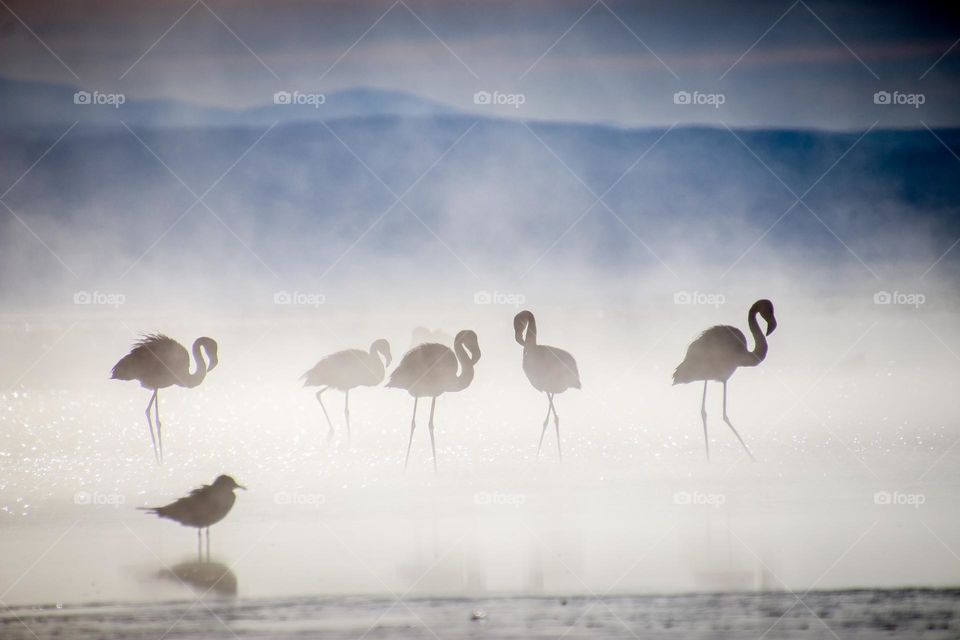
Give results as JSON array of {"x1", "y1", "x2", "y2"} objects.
[{"x1": 0, "y1": 590, "x2": 960, "y2": 640}]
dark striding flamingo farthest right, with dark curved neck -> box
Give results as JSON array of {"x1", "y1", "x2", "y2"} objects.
[{"x1": 673, "y1": 300, "x2": 777, "y2": 462}]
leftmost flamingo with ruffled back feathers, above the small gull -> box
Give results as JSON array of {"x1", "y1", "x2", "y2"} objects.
[{"x1": 110, "y1": 333, "x2": 218, "y2": 464}]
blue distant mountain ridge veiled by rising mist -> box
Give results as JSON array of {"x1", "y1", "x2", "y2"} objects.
[{"x1": 0, "y1": 76, "x2": 960, "y2": 294}]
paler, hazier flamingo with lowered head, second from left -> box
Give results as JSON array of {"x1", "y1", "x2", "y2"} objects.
[{"x1": 301, "y1": 338, "x2": 392, "y2": 442}]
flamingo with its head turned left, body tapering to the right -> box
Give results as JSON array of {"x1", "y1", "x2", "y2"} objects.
[{"x1": 513, "y1": 311, "x2": 580, "y2": 460}]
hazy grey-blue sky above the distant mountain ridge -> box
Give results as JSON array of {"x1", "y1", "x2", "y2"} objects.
[{"x1": 0, "y1": 0, "x2": 960, "y2": 128}]
